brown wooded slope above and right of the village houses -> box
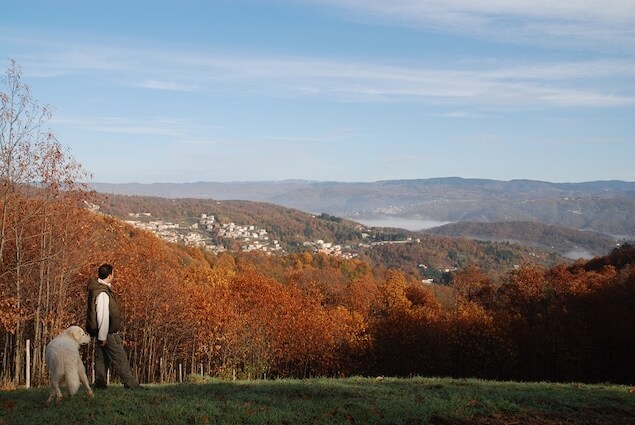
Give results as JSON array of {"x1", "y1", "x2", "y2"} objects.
[{"x1": 99, "y1": 195, "x2": 565, "y2": 281}]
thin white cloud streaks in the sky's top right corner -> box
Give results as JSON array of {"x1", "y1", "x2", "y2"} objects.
[{"x1": 312, "y1": 0, "x2": 635, "y2": 52}]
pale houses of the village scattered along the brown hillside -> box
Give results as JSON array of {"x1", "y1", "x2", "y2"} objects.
[{"x1": 86, "y1": 202, "x2": 549, "y2": 284}]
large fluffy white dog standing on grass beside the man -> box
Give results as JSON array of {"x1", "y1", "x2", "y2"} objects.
[{"x1": 46, "y1": 326, "x2": 93, "y2": 404}]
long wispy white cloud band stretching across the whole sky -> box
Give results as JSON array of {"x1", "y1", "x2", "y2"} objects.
[{"x1": 0, "y1": 29, "x2": 635, "y2": 109}]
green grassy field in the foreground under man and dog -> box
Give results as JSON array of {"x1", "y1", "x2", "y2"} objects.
[{"x1": 0, "y1": 377, "x2": 635, "y2": 425}]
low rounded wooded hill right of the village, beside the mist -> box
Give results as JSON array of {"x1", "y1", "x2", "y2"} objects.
[{"x1": 425, "y1": 221, "x2": 618, "y2": 259}]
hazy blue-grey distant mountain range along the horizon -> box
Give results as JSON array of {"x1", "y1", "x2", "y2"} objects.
[{"x1": 92, "y1": 177, "x2": 635, "y2": 239}]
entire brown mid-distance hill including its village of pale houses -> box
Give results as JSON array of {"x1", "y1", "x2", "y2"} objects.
[{"x1": 97, "y1": 195, "x2": 567, "y2": 284}]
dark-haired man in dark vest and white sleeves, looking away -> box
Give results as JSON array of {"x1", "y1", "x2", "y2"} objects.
[{"x1": 86, "y1": 264, "x2": 140, "y2": 389}]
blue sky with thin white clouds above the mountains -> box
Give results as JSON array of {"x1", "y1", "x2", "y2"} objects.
[{"x1": 0, "y1": 0, "x2": 635, "y2": 183}]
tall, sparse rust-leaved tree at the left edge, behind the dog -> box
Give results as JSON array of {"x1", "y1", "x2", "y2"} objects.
[{"x1": 0, "y1": 61, "x2": 92, "y2": 384}]
